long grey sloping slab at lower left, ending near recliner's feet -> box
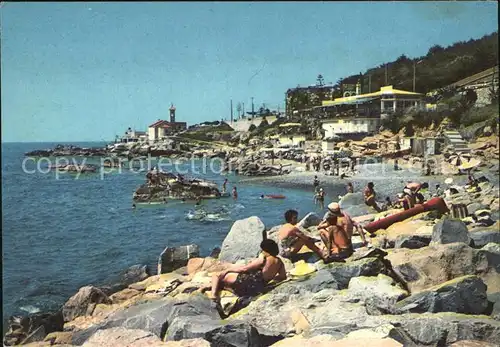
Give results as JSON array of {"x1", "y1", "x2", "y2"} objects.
[{"x1": 72, "y1": 295, "x2": 220, "y2": 346}]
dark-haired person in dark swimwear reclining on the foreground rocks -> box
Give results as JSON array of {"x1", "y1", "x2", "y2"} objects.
[{"x1": 212, "y1": 239, "x2": 286, "y2": 302}]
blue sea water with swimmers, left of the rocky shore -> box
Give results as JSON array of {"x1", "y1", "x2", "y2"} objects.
[{"x1": 2, "y1": 143, "x2": 336, "y2": 323}]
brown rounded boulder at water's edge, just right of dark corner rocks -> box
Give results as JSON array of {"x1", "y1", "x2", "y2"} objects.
[{"x1": 62, "y1": 286, "x2": 111, "y2": 322}]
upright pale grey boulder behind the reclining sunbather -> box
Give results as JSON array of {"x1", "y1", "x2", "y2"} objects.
[{"x1": 219, "y1": 216, "x2": 266, "y2": 263}]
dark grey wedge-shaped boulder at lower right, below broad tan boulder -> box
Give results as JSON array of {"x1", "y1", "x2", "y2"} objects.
[{"x1": 396, "y1": 276, "x2": 488, "y2": 314}]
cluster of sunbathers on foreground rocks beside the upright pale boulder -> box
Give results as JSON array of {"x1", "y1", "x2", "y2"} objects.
[{"x1": 211, "y1": 203, "x2": 367, "y2": 302}]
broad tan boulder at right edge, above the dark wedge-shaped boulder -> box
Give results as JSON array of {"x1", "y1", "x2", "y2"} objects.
[{"x1": 386, "y1": 243, "x2": 500, "y2": 293}]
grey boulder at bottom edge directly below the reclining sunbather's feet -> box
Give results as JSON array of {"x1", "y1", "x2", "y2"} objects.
[{"x1": 165, "y1": 315, "x2": 262, "y2": 347}]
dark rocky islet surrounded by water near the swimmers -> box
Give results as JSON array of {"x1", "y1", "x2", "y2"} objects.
[{"x1": 133, "y1": 172, "x2": 221, "y2": 203}]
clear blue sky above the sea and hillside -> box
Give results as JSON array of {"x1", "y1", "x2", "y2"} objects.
[{"x1": 0, "y1": 1, "x2": 498, "y2": 142}]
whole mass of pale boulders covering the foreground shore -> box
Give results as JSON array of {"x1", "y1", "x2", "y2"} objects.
[{"x1": 6, "y1": 204, "x2": 500, "y2": 347}]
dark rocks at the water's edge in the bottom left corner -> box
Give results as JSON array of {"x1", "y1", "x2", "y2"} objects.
[{"x1": 3, "y1": 311, "x2": 64, "y2": 346}]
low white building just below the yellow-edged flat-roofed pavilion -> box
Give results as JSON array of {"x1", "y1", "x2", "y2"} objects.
[{"x1": 322, "y1": 117, "x2": 380, "y2": 138}]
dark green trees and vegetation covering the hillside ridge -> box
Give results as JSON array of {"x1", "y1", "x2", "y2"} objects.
[{"x1": 287, "y1": 32, "x2": 498, "y2": 114}]
